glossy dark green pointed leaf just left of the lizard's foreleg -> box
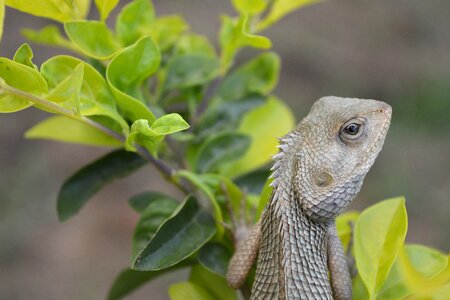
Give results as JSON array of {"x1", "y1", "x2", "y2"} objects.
[{"x1": 133, "y1": 196, "x2": 216, "y2": 271}]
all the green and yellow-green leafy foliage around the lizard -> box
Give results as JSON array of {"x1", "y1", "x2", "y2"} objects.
[{"x1": 0, "y1": 0, "x2": 450, "y2": 300}]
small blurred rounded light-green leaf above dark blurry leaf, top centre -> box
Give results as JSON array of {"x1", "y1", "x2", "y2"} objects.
[{"x1": 174, "y1": 33, "x2": 216, "y2": 57}]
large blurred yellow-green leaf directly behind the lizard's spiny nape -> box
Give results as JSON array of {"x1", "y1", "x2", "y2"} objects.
[{"x1": 223, "y1": 97, "x2": 295, "y2": 177}]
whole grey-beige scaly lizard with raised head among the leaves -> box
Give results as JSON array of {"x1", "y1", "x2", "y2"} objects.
[{"x1": 227, "y1": 96, "x2": 392, "y2": 300}]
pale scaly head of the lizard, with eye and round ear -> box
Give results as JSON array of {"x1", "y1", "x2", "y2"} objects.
[{"x1": 294, "y1": 97, "x2": 392, "y2": 222}]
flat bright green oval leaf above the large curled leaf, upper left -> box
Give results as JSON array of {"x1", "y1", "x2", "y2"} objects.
[{"x1": 64, "y1": 21, "x2": 119, "y2": 60}]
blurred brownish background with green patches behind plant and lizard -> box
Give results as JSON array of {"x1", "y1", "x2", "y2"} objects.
[{"x1": 0, "y1": 0, "x2": 450, "y2": 300}]
